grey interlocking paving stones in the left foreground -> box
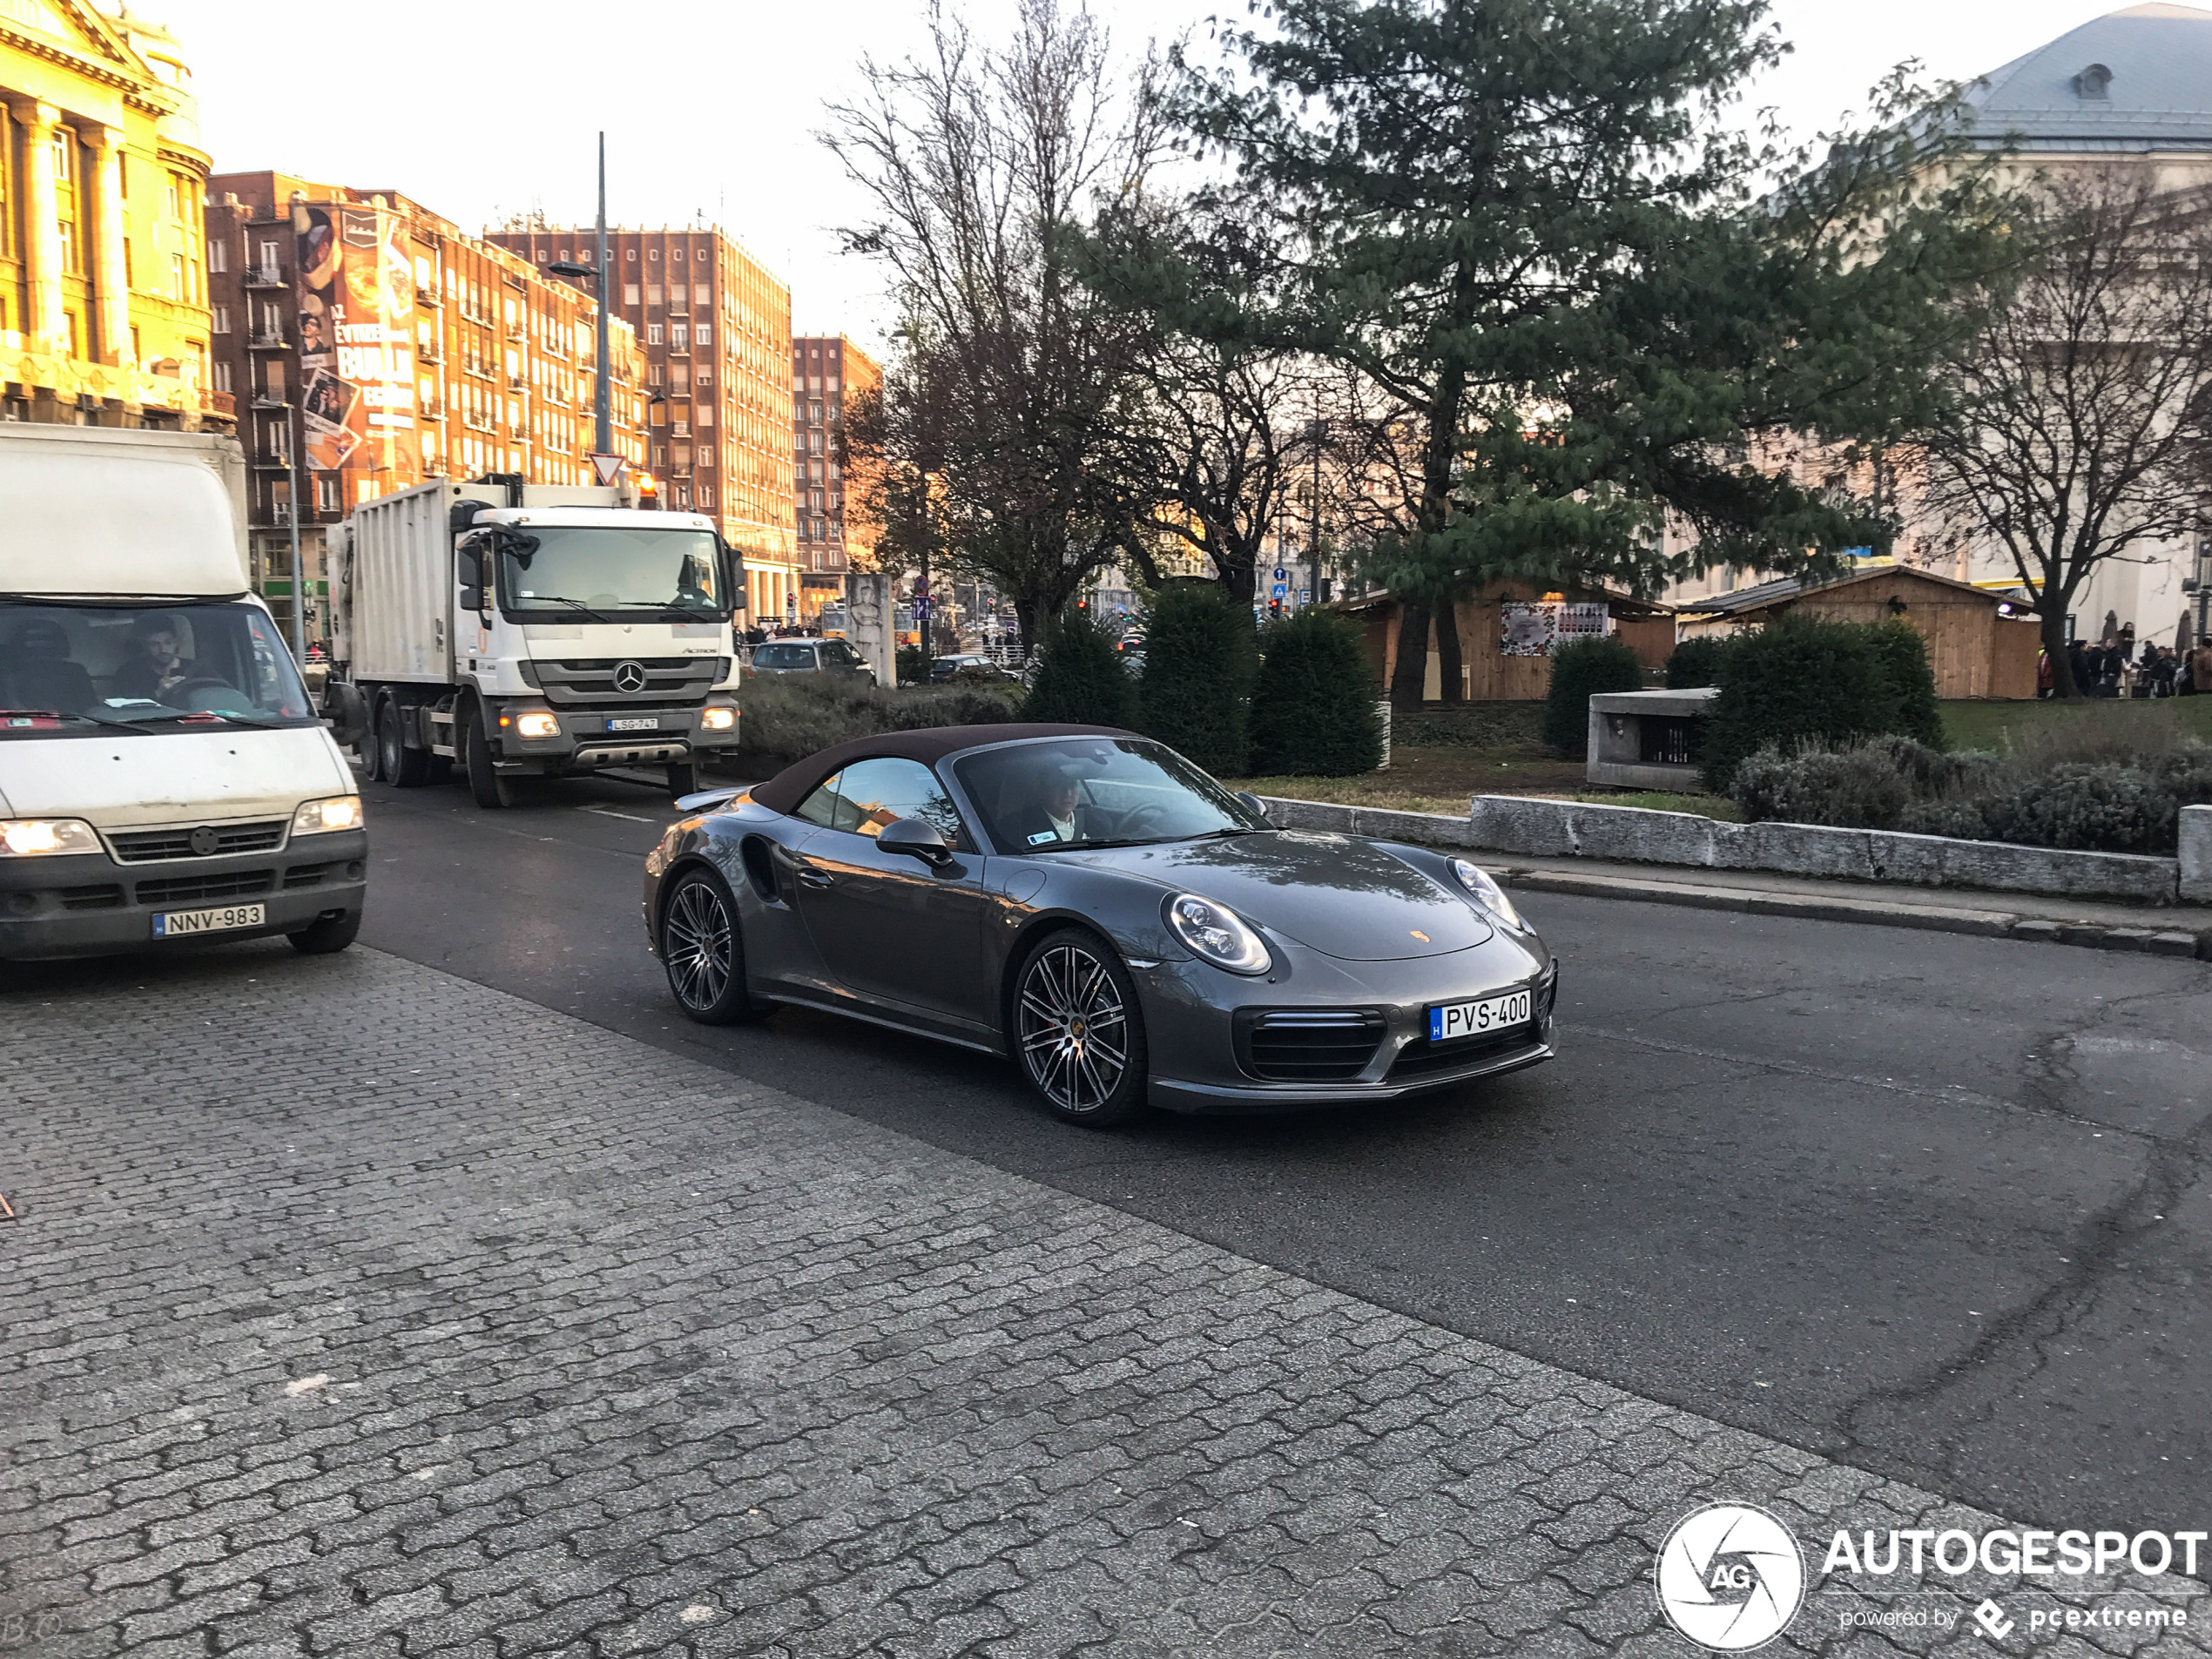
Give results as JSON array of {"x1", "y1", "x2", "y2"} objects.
[{"x1": 0, "y1": 947, "x2": 2212, "y2": 1659}]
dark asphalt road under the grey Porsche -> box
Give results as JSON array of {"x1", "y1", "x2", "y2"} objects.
[{"x1": 280, "y1": 781, "x2": 2212, "y2": 1531}]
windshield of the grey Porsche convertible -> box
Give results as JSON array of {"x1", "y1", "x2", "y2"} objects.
[{"x1": 954, "y1": 737, "x2": 1267, "y2": 853}]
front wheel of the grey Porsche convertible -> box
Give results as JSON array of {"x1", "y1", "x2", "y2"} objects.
[{"x1": 1013, "y1": 929, "x2": 1146, "y2": 1128}]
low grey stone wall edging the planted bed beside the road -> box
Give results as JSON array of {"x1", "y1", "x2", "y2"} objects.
[{"x1": 1267, "y1": 794, "x2": 2212, "y2": 905}]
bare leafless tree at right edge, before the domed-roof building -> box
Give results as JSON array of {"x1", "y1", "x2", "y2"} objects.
[{"x1": 1925, "y1": 168, "x2": 2212, "y2": 697}]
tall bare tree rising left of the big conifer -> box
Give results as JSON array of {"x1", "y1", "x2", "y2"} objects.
[{"x1": 823, "y1": 0, "x2": 1162, "y2": 642}]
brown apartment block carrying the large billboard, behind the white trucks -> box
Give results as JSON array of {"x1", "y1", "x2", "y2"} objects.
[{"x1": 208, "y1": 172, "x2": 652, "y2": 637}]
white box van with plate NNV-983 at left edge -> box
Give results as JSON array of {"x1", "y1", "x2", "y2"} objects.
[{"x1": 0, "y1": 422, "x2": 369, "y2": 960}]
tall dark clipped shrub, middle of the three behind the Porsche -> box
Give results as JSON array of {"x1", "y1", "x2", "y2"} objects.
[{"x1": 1137, "y1": 582, "x2": 1258, "y2": 779}]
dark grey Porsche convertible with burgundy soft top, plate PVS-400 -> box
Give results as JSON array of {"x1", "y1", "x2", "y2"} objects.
[{"x1": 644, "y1": 725, "x2": 1560, "y2": 1126}]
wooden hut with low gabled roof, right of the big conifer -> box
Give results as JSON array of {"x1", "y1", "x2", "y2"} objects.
[{"x1": 1681, "y1": 564, "x2": 2041, "y2": 697}]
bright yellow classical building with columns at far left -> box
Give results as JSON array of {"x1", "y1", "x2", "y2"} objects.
[{"x1": 0, "y1": 4, "x2": 233, "y2": 431}]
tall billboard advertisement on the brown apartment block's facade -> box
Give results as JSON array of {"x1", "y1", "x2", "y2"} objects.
[{"x1": 294, "y1": 204, "x2": 422, "y2": 480}]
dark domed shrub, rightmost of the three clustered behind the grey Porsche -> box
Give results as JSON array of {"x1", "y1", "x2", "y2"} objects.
[{"x1": 1252, "y1": 610, "x2": 1383, "y2": 779}]
